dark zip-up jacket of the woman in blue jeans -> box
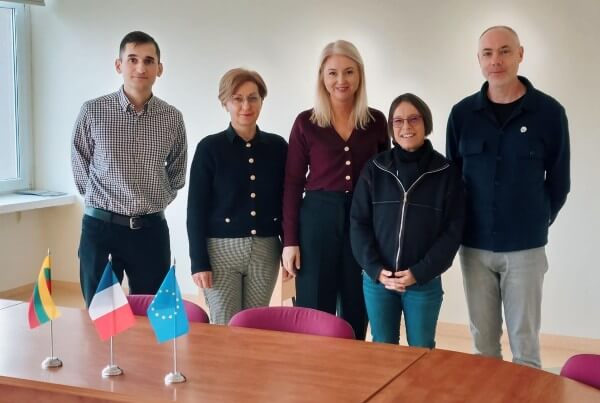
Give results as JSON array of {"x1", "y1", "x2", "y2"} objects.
[{"x1": 350, "y1": 144, "x2": 465, "y2": 284}]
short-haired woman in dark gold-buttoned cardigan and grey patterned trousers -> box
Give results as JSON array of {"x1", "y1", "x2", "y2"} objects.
[{"x1": 187, "y1": 68, "x2": 287, "y2": 325}]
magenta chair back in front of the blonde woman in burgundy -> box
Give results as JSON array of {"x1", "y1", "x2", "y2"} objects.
[{"x1": 229, "y1": 306, "x2": 354, "y2": 339}]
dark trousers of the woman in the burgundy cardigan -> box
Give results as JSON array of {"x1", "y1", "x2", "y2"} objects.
[{"x1": 296, "y1": 191, "x2": 368, "y2": 340}]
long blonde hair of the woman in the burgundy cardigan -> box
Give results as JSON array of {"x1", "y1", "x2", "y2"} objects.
[{"x1": 310, "y1": 40, "x2": 373, "y2": 129}]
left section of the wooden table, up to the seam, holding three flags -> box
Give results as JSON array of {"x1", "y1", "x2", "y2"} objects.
[{"x1": 0, "y1": 304, "x2": 427, "y2": 402}]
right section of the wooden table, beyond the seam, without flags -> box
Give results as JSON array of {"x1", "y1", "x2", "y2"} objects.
[{"x1": 369, "y1": 349, "x2": 600, "y2": 403}]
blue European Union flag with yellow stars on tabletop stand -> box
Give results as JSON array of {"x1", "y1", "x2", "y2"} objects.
[{"x1": 147, "y1": 266, "x2": 190, "y2": 343}]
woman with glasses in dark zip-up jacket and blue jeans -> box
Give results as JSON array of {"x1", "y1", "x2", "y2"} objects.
[{"x1": 350, "y1": 94, "x2": 465, "y2": 348}]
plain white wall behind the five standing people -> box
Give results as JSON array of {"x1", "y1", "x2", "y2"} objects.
[{"x1": 0, "y1": 0, "x2": 600, "y2": 338}]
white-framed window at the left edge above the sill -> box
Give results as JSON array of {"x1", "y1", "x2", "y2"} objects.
[{"x1": 0, "y1": 1, "x2": 32, "y2": 192}]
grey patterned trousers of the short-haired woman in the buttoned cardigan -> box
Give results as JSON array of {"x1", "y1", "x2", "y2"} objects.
[{"x1": 204, "y1": 237, "x2": 281, "y2": 325}]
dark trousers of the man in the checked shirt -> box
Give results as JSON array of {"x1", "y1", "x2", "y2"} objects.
[{"x1": 79, "y1": 215, "x2": 171, "y2": 307}]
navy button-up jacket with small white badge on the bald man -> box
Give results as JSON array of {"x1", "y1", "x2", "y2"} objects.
[{"x1": 446, "y1": 77, "x2": 571, "y2": 252}]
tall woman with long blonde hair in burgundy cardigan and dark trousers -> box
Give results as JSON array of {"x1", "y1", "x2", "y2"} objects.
[{"x1": 282, "y1": 40, "x2": 390, "y2": 339}]
